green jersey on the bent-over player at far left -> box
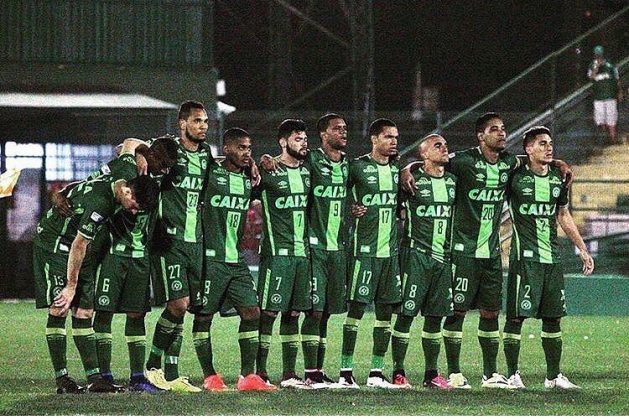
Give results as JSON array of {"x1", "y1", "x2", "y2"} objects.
[{"x1": 36, "y1": 177, "x2": 120, "y2": 254}]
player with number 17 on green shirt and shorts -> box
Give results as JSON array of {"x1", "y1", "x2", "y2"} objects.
[{"x1": 339, "y1": 118, "x2": 401, "y2": 388}]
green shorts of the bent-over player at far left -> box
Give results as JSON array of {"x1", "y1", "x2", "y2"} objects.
[{"x1": 33, "y1": 244, "x2": 95, "y2": 309}]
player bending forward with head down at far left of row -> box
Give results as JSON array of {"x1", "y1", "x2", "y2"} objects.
[{"x1": 33, "y1": 176, "x2": 157, "y2": 394}]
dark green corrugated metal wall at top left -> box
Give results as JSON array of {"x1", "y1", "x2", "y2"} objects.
[{"x1": 0, "y1": 0, "x2": 212, "y2": 66}]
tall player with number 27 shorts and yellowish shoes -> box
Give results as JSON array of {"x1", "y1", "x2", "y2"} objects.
[{"x1": 145, "y1": 101, "x2": 214, "y2": 392}]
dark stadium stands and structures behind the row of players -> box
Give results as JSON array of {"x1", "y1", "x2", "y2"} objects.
[{"x1": 0, "y1": 0, "x2": 629, "y2": 315}]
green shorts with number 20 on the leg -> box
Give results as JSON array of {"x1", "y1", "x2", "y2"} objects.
[{"x1": 452, "y1": 254, "x2": 502, "y2": 312}]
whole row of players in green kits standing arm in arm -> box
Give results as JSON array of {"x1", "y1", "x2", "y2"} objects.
[{"x1": 33, "y1": 101, "x2": 594, "y2": 394}]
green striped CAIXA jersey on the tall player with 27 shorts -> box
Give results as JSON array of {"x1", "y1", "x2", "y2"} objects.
[{"x1": 157, "y1": 139, "x2": 214, "y2": 243}]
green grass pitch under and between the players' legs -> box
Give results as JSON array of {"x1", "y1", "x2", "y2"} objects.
[{"x1": 0, "y1": 303, "x2": 629, "y2": 415}]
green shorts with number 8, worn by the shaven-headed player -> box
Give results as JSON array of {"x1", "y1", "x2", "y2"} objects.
[{"x1": 400, "y1": 247, "x2": 454, "y2": 317}]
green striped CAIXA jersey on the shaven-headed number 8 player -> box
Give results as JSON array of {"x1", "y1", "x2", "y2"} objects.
[{"x1": 402, "y1": 168, "x2": 456, "y2": 262}]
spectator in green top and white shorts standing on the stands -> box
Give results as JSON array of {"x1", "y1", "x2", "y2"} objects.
[{"x1": 588, "y1": 45, "x2": 622, "y2": 144}]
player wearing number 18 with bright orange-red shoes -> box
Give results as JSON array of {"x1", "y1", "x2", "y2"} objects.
[{"x1": 192, "y1": 128, "x2": 277, "y2": 391}]
